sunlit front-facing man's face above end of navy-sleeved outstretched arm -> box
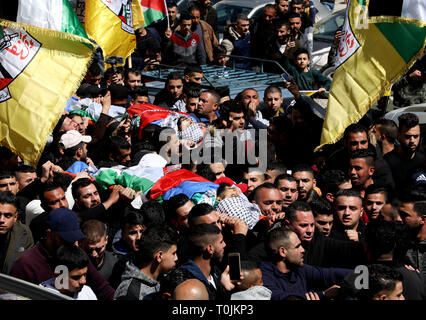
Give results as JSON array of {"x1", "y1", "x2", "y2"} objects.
[{"x1": 334, "y1": 196, "x2": 362, "y2": 229}]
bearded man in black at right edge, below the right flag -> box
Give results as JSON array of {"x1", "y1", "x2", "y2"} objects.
[{"x1": 383, "y1": 113, "x2": 425, "y2": 192}]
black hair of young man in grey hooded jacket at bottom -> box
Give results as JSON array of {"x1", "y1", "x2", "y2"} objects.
[{"x1": 134, "y1": 225, "x2": 178, "y2": 268}]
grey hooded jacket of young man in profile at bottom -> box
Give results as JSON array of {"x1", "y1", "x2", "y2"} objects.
[{"x1": 114, "y1": 261, "x2": 160, "y2": 300}]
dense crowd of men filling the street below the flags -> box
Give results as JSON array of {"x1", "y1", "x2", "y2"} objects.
[{"x1": 0, "y1": 0, "x2": 426, "y2": 302}]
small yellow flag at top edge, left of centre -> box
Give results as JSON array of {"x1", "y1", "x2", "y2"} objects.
[{"x1": 84, "y1": 0, "x2": 143, "y2": 60}]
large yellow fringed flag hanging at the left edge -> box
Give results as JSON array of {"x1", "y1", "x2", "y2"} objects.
[{"x1": 0, "y1": 19, "x2": 94, "y2": 166}]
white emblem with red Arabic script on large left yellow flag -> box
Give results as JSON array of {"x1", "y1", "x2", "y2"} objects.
[{"x1": 0, "y1": 26, "x2": 41, "y2": 102}]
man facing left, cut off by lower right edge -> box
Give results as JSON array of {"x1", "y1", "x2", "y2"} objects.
[{"x1": 399, "y1": 185, "x2": 426, "y2": 277}]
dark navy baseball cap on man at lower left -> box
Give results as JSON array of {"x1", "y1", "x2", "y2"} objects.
[{"x1": 47, "y1": 207, "x2": 86, "y2": 243}]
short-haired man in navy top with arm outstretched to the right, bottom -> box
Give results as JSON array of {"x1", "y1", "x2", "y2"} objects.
[{"x1": 260, "y1": 228, "x2": 352, "y2": 300}]
